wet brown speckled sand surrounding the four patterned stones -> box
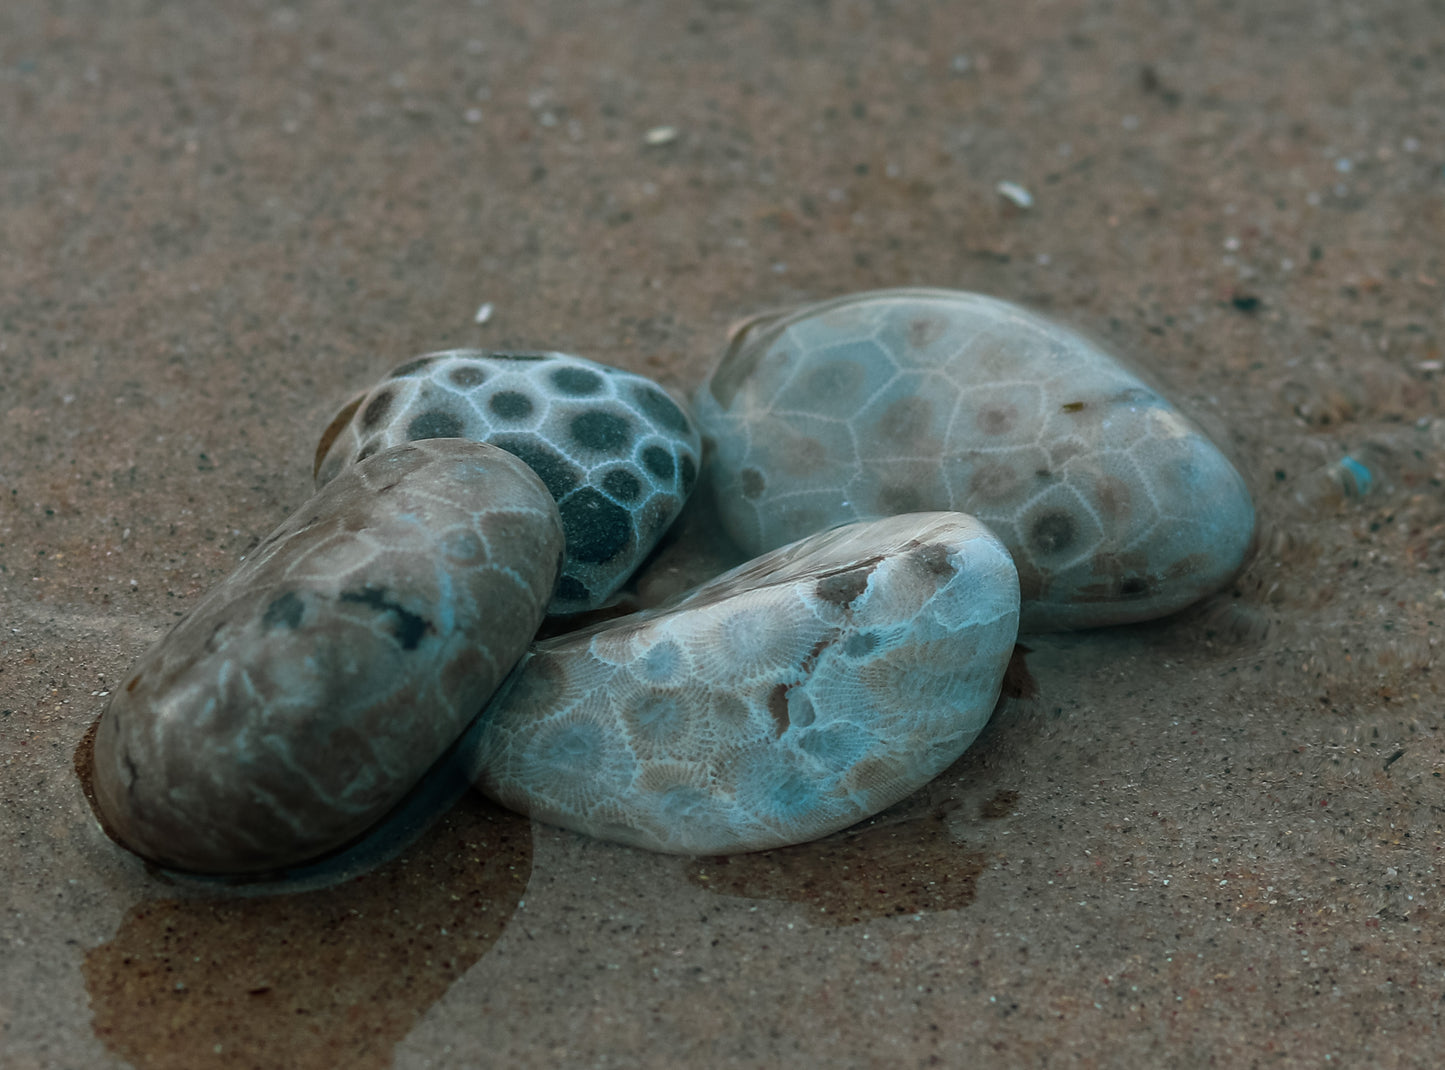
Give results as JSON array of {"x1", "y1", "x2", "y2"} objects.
[{"x1": 0, "y1": 0, "x2": 1445, "y2": 1070}]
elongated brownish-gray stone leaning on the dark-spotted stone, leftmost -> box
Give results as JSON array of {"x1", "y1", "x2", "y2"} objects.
[{"x1": 94, "y1": 440, "x2": 562, "y2": 873}]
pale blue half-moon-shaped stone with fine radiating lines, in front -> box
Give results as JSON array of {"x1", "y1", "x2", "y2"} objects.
[{"x1": 473, "y1": 513, "x2": 1019, "y2": 855}]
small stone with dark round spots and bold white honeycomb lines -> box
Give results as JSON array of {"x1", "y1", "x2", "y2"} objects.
[{"x1": 315, "y1": 350, "x2": 701, "y2": 613}]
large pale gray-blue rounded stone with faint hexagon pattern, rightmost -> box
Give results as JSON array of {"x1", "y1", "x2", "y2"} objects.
[{"x1": 695, "y1": 289, "x2": 1254, "y2": 630}]
